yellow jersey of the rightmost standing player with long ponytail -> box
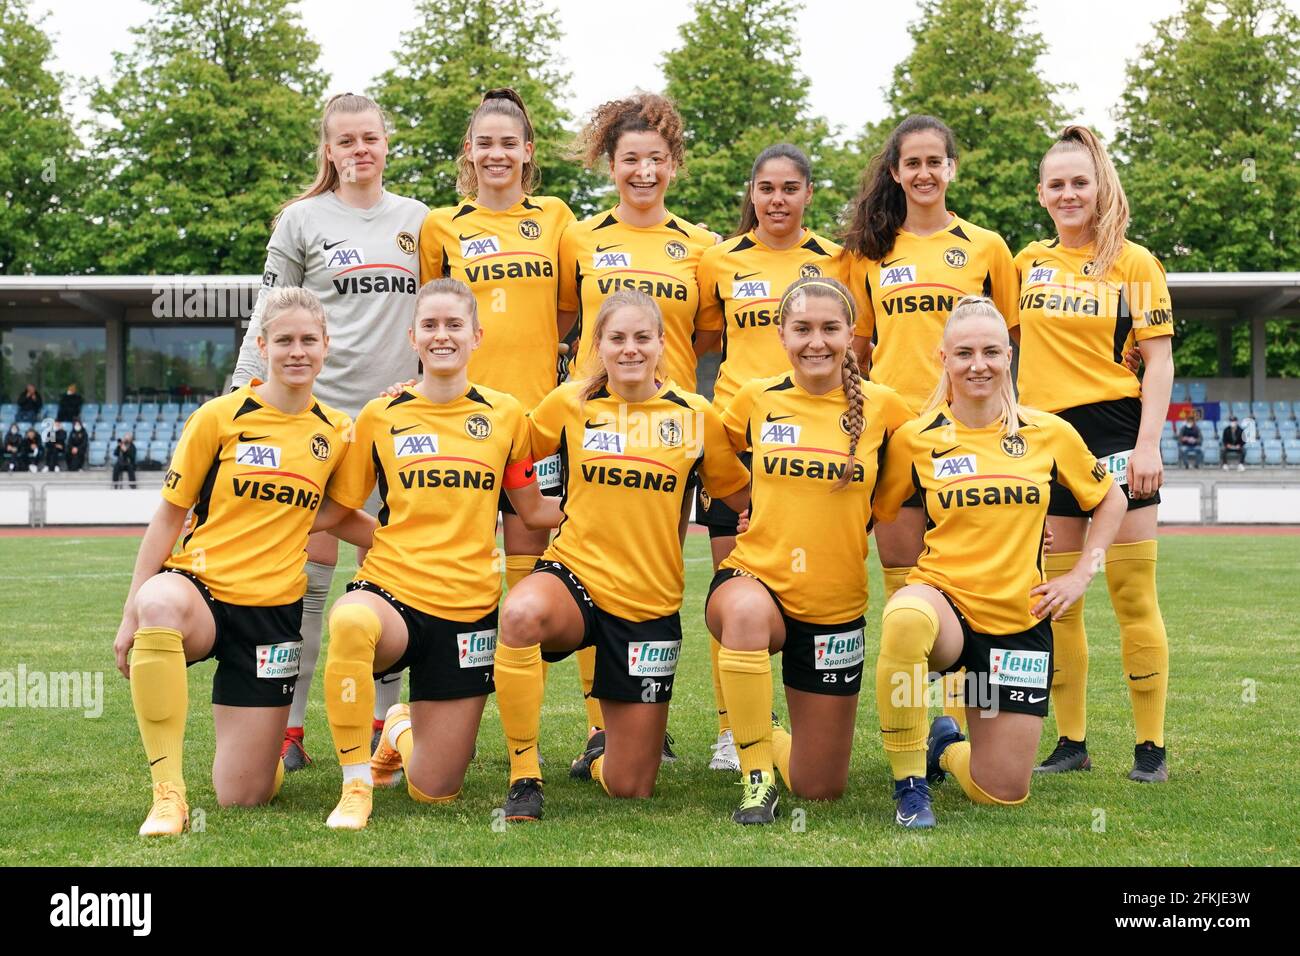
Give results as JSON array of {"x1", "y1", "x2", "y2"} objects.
[{"x1": 1013, "y1": 238, "x2": 1174, "y2": 411}]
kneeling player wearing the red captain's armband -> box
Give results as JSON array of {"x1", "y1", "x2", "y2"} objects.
[{"x1": 325, "y1": 278, "x2": 562, "y2": 830}]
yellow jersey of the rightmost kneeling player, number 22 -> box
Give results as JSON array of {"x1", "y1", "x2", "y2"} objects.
[{"x1": 875, "y1": 405, "x2": 1112, "y2": 635}]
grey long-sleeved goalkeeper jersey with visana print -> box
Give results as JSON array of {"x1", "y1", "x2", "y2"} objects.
[{"x1": 233, "y1": 191, "x2": 429, "y2": 418}]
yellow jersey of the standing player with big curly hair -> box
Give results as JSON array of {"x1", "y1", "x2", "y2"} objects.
[{"x1": 560, "y1": 209, "x2": 714, "y2": 392}]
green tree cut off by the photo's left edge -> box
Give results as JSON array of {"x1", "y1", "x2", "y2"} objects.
[{"x1": 0, "y1": 0, "x2": 81, "y2": 274}]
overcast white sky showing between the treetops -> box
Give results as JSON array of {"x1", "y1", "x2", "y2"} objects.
[{"x1": 33, "y1": 0, "x2": 1300, "y2": 134}]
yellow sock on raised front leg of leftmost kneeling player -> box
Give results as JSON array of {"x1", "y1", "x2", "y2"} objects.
[{"x1": 131, "y1": 627, "x2": 190, "y2": 790}]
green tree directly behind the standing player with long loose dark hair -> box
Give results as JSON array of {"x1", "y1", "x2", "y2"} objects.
[{"x1": 861, "y1": 0, "x2": 1069, "y2": 254}]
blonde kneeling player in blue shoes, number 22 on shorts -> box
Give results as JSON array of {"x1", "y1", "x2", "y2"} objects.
[{"x1": 875, "y1": 297, "x2": 1126, "y2": 827}]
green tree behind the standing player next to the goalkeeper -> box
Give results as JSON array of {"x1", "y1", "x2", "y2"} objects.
[{"x1": 373, "y1": 0, "x2": 594, "y2": 216}]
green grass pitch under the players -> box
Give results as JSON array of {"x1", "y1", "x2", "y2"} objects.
[{"x1": 0, "y1": 535, "x2": 1300, "y2": 866}]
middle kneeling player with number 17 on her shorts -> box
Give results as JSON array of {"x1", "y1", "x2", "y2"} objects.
[{"x1": 497, "y1": 289, "x2": 749, "y2": 821}]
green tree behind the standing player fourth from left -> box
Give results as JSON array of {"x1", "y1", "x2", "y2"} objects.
[{"x1": 663, "y1": 0, "x2": 858, "y2": 233}]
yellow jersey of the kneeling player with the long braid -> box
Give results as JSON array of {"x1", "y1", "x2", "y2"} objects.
[{"x1": 722, "y1": 375, "x2": 911, "y2": 624}]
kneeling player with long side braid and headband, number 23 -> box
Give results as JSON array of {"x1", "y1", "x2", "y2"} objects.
[{"x1": 705, "y1": 278, "x2": 911, "y2": 823}]
